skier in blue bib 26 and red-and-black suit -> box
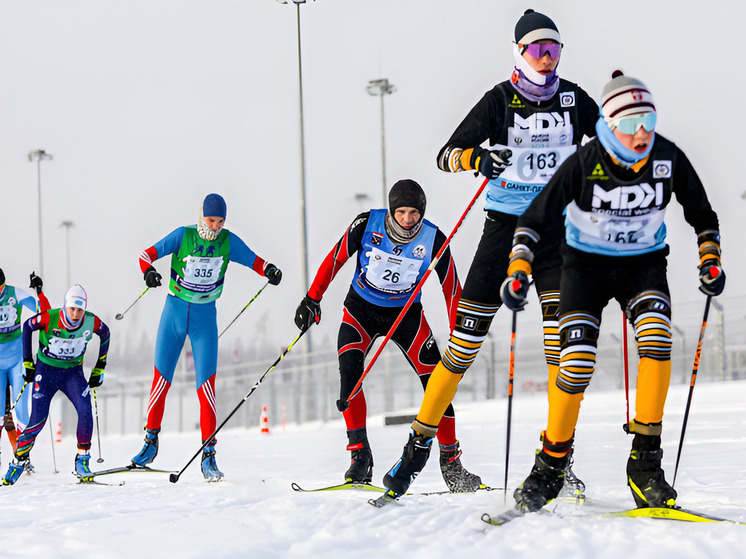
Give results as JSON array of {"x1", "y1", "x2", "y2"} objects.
[{"x1": 295, "y1": 180, "x2": 482, "y2": 492}]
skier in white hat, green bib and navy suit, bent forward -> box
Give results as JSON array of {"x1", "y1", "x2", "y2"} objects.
[{"x1": 3, "y1": 285, "x2": 109, "y2": 485}]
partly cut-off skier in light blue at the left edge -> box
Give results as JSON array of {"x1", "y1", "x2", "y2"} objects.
[{"x1": 0, "y1": 270, "x2": 49, "y2": 466}]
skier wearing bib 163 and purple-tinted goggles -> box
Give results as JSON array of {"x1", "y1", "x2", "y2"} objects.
[{"x1": 384, "y1": 10, "x2": 598, "y2": 494}]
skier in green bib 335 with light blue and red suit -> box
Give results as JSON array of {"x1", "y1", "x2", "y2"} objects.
[{"x1": 132, "y1": 194, "x2": 282, "y2": 480}]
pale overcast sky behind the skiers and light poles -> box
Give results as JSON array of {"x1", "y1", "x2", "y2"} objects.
[{"x1": 0, "y1": 0, "x2": 746, "y2": 358}]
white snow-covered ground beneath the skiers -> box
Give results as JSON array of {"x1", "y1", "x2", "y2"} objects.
[{"x1": 0, "y1": 382, "x2": 746, "y2": 559}]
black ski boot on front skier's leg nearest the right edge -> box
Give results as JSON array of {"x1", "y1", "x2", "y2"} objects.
[{"x1": 627, "y1": 433, "x2": 677, "y2": 508}]
